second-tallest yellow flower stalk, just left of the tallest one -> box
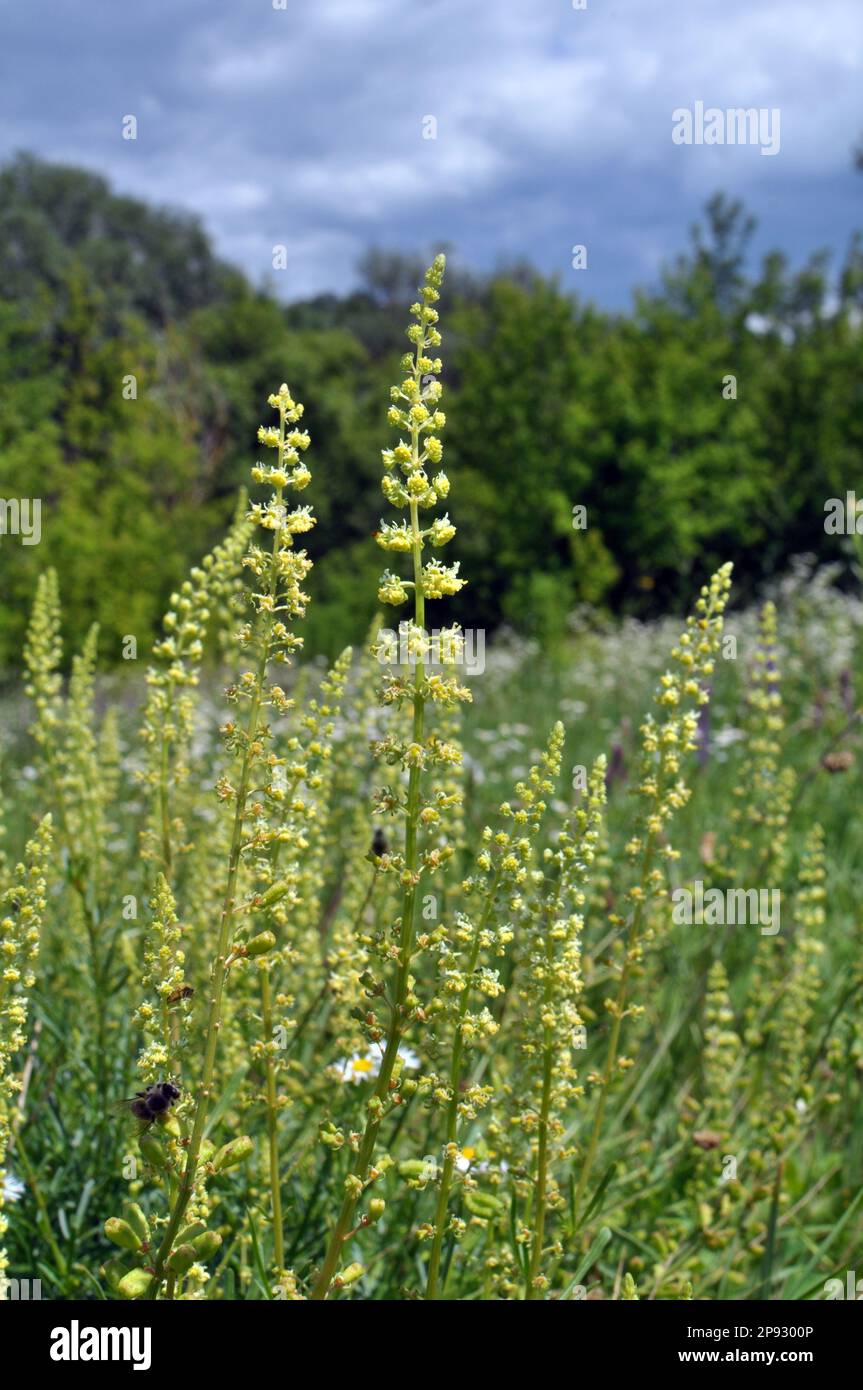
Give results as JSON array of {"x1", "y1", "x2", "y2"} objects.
[{"x1": 147, "y1": 384, "x2": 314, "y2": 1297}]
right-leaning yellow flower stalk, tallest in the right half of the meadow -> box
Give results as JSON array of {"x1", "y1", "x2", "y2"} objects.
[{"x1": 574, "y1": 564, "x2": 731, "y2": 1218}]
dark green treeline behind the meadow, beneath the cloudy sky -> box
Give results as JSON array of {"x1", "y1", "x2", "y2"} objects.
[{"x1": 0, "y1": 156, "x2": 863, "y2": 667}]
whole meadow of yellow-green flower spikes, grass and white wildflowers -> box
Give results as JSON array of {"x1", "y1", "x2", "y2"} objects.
[{"x1": 0, "y1": 256, "x2": 863, "y2": 1301}]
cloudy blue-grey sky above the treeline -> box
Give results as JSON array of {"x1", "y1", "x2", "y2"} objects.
[{"x1": 0, "y1": 0, "x2": 863, "y2": 306}]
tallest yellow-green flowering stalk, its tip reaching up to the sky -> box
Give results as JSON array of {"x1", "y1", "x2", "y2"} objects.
[{"x1": 311, "y1": 256, "x2": 470, "y2": 1300}]
